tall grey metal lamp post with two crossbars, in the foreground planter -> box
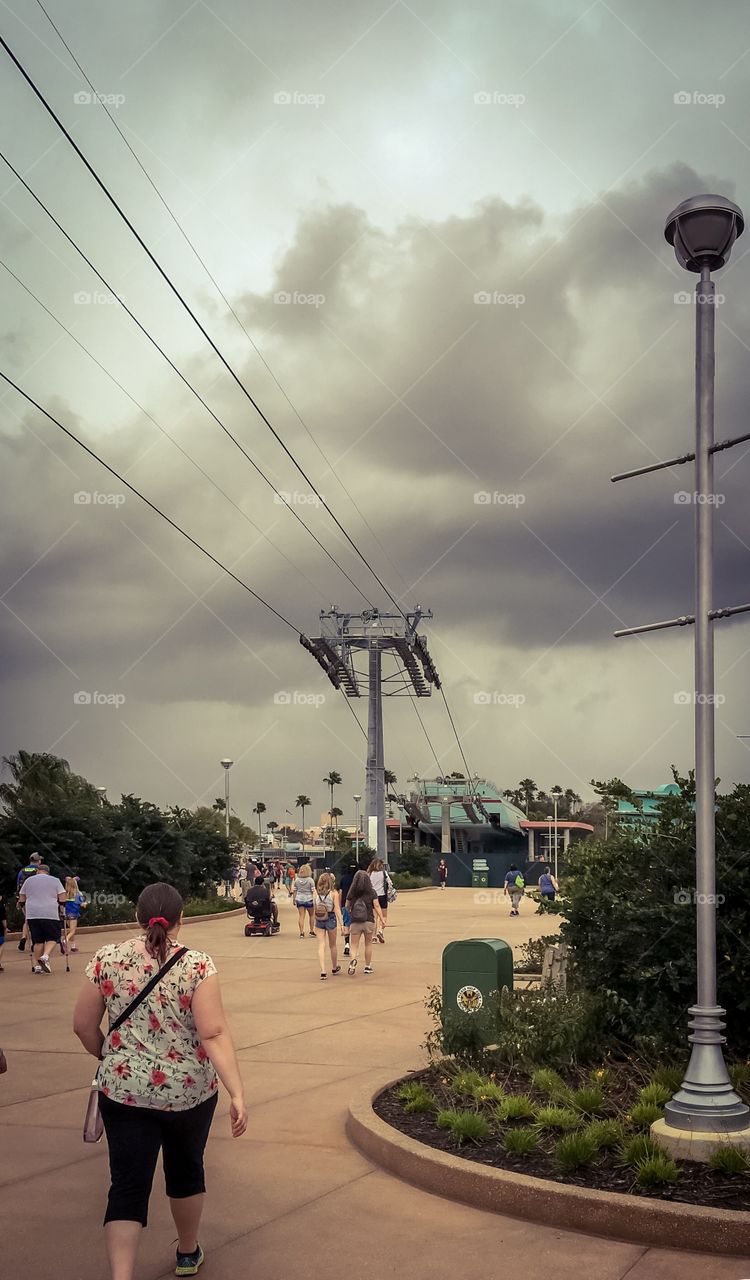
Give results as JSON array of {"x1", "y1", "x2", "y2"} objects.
[{"x1": 612, "y1": 196, "x2": 750, "y2": 1137}]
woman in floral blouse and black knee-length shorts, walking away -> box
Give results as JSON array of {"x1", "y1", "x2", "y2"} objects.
[{"x1": 73, "y1": 884, "x2": 247, "y2": 1280}]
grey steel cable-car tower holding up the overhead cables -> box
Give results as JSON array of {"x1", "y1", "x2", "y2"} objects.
[{"x1": 299, "y1": 605, "x2": 440, "y2": 859}]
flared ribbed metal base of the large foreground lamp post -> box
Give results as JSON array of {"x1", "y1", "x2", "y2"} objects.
[{"x1": 664, "y1": 1005, "x2": 750, "y2": 1134}]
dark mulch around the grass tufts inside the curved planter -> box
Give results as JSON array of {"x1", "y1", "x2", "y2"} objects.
[{"x1": 374, "y1": 1068, "x2": 750, "y2": 1212}]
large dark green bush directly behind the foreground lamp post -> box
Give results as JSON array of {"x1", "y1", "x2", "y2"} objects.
[{"x1": 561, "y1": 774, "x2": 750, "y2": 1057}]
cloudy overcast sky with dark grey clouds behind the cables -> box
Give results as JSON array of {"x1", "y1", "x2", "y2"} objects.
[{"x1": 0, "y1": 0, "x2": 750, "y2": 822}]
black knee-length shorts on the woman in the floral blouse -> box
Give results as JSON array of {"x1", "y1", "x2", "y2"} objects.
[{"x1": 99, "y1": 1093, "x2": 219, "y2": 1226}]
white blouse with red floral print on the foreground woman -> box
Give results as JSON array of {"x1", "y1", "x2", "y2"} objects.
[{"x1": 86, "y1": 938, "x2": 219, "y2": 1111}]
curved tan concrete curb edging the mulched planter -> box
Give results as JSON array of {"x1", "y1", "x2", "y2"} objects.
[{"x1": 347, "y1": 1076, "x2": 750, "y2": 1257}]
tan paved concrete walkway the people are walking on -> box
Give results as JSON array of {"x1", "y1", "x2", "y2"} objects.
[{"x1": 0, "y1": 890, "x2": 750, "y2": 1280}]
